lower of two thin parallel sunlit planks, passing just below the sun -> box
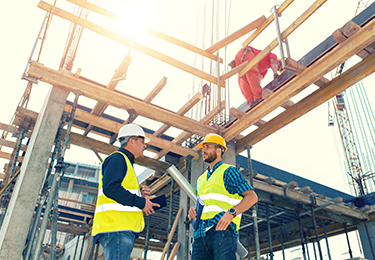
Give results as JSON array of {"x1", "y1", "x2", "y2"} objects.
[{"x1": 38, "y1": 1, "x2": 225, "y2": 87}]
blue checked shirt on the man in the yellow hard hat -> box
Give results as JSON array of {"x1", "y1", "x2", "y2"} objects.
[{"x1": 194, "y1": 162, "x2": 253, "y2": 239}]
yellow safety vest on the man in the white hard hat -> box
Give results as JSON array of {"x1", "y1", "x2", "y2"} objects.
[{"x1": 92, "y1": 151, "x2": 145, "y2": 236}]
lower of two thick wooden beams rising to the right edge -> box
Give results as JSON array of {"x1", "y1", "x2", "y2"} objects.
[{"x1": 236, "y1": 49, "x2": 375, "y2": 154}]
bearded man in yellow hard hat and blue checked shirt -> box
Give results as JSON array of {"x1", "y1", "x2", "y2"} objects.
[{"x1": 189, "y1": 134, "x2": 258, "y2": 260}]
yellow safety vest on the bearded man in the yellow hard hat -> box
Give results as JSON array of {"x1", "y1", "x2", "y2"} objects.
[{"x1": 197, "y1": 163, "x2": 242, "y2": 230}]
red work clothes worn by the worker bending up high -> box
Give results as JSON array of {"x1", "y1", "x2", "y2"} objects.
[{"x1": 234, "y1": 46, "x2": 277, "y2": 104}]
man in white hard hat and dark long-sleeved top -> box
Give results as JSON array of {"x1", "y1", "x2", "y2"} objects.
[{"x1": 92, "y1": 124, "x2": 160, "y2": 260}]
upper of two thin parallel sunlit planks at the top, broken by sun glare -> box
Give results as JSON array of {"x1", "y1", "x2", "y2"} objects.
[{"x1": 67, "y1": 0, "x2": 223, "y2": 63}]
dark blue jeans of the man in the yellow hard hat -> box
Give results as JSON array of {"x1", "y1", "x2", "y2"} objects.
[{"x1": 191, "y1": 225, "x2": 237, "y2": 260}]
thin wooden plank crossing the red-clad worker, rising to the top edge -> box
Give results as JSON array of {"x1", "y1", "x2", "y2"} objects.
[{"x1": 240, "y1": 0, "x2": 327, "y2": 77}]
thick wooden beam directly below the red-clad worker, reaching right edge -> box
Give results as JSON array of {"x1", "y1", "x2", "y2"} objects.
[{"x1": 223, "y1": 13, "x2": 375, "y2": 141}]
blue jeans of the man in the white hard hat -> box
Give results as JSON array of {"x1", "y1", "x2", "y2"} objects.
[{"x1": 99, "y1": 231, "x2": 136, "y2": 260}]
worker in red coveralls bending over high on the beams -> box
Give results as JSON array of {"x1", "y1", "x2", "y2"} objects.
[{"x1": 228, "y1": 46, "x2": 281, "y2": 107}]
